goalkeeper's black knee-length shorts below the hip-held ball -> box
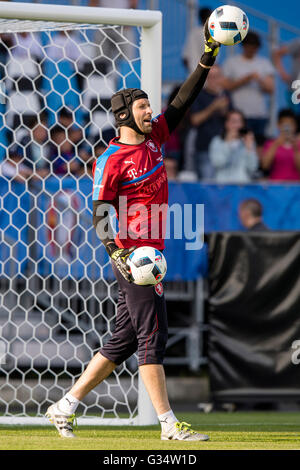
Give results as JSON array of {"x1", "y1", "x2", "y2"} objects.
[{"x1": 100, "y1": 263, "x2": 168, "y2": 365}]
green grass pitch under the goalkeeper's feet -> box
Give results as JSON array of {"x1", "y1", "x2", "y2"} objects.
[{"x1": 0, "y1": 412, "x2": 300, "y2": 450}]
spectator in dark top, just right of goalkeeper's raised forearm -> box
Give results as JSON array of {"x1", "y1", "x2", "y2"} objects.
[{"x1": 188, "y1": 65, "x2": 230, "y2": 180}]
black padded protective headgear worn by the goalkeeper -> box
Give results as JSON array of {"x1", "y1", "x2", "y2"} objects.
[{"x1": 111, "y1": 88, "x2": 148, "y2": 134}]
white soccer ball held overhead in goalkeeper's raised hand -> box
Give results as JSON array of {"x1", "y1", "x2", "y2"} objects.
[{"x1": 208, "y1": 5, "x2": 249, "y2": 46}]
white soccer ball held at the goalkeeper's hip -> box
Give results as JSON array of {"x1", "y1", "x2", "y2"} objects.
[{"x1": 127, "y1": 246, "x2": 167, "y2": 286}]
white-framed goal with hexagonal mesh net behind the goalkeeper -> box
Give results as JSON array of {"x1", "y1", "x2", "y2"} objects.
[{"x1": 0, "y1": 2, "x2": 161, "y2": 424}]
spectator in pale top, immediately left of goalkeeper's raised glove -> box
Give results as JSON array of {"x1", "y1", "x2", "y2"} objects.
[{"x1": 182, "y1": 7, "x2": 212, "y2": 73}]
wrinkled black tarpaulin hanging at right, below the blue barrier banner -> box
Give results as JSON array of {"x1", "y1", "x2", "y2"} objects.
[{"x1": 208, "y1": 232, "x2": 300, "y2": 401}]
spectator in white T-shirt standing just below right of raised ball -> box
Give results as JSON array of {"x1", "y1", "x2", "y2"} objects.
[{"x1": 223, "y1": 31, "x2": 275, "y2": 135}]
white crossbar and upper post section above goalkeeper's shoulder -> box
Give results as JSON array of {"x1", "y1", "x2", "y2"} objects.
[{"x1": 0, "y1": 2, "x2": 162, "y2": 114}]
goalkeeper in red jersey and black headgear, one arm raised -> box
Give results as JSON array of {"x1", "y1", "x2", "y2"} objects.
[{"x1": 46, "y1": 24, "x2": 220, "y2": 441}]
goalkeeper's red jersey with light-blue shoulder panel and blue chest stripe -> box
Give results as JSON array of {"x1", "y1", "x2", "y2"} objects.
[{"x1": 93, "y1": 114, "x2": 169, "y2": 250}]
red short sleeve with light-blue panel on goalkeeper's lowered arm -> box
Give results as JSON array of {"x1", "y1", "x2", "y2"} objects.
[{"x1": 93, "y1": 153, "x2": 120, "y2": 201}]
